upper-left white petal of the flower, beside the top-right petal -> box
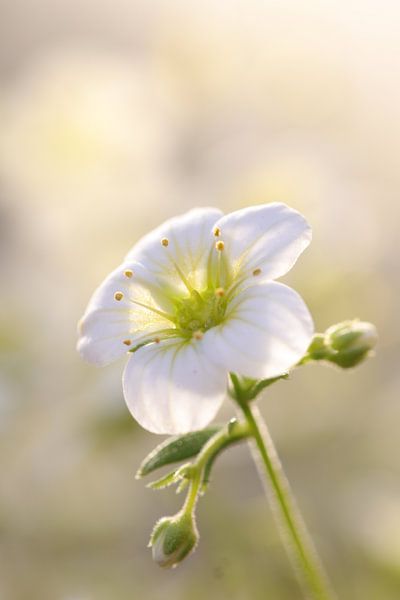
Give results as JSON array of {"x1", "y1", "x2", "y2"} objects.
[{"x1": 126, "y1": 208, "x2": 222, "y2": 292}]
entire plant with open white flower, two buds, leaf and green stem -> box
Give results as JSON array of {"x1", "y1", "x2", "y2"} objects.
[{"x1": 77, "y1": 203, "x2": 377, "y2": 600}]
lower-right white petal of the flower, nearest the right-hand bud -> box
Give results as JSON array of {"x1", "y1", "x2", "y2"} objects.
[{"x1": 201, "y1": 282, "x2": 314, "y2": 379}]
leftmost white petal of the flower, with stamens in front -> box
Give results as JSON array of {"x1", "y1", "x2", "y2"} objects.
[{"x1": 77, "y1": 262, "x2": 175, "y2": 366}]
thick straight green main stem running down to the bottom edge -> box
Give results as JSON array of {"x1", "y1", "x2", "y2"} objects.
[{"x1": 234, "y1": 384, "x2": 334, "y2": 600}]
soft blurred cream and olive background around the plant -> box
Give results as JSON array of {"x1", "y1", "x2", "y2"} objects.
[{"x1": 0, "y1": 0, "x2": 400, "y2": 600}]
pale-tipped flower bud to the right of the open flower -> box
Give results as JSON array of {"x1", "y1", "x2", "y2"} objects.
[{"x1": 325, "y1": 320, "x2": 378, "y2": 369}]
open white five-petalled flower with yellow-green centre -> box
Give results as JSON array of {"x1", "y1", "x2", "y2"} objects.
[{"x1": 78, "y1": 203, "x2": 313, "y2": 433}]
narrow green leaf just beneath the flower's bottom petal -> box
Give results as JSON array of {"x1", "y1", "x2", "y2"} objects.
[{"x1": 136, "y1": 425, "x2": 222, "y2": 478}]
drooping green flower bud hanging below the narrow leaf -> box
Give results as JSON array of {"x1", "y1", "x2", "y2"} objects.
[{"x1": 149, "y1": 511, "x2": 199, "y2": 567}]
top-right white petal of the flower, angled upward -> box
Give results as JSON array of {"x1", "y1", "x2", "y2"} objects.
[{"x1": 216, "y1": 202, "x2": 311, "y2": 282}]
